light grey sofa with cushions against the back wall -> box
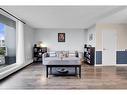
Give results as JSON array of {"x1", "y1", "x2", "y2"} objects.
[{"x1": 42, "y1": 51, "x2": 83, "y2": 65}]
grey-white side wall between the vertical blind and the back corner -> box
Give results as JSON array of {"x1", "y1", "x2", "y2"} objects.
[{"x1": 24, "y1": 24, "x2": 34, "y2": 62}]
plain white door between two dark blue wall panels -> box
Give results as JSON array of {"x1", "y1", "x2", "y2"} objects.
[{"x1": 102, "y1": 30, "x2": 117, "y2": 66}]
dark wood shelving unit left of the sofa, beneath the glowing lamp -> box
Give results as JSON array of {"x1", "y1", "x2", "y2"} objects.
[{"x1": 33, "y1": 47, "x2": 47, "y2": 62}]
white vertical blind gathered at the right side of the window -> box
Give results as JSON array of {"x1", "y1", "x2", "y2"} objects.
[{"x1": 16, "y1": 21, "x2": 25, "y2": 64}]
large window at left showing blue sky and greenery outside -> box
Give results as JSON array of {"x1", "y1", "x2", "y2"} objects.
[{"x1": 0, "y1": 14, "x2": 16, "y2": 69}]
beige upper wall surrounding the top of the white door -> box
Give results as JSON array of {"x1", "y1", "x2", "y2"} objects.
[{"x1": 96, "y1": 23, "x2": 127, "y2": 51}]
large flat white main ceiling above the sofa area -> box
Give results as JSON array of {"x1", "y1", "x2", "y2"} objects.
[{"x1": 2, "y1": 6, "x2": 127, "y2": 29}]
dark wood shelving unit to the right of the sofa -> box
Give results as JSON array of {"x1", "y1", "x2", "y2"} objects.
[{"x1": 84, "y1": 47, "x2": 95, "y2": 65}]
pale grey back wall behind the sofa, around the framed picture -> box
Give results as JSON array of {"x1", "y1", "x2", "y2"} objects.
[{"x1": 34, "y1": 29, "x2": 86, "y2": 51}]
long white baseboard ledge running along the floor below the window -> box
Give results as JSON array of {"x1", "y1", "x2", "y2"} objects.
[{"x1": 0, "y1": 59, "x2": 33, "y2": 80}]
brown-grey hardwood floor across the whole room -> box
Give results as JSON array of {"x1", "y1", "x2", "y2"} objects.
[{"x1": 0, "y1": 63, "x2": 127, "y2": 89}]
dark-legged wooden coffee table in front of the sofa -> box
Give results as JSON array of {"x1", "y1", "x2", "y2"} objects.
[{"x1": 46, "y1": 60, "x2": 81, "y2": 78}]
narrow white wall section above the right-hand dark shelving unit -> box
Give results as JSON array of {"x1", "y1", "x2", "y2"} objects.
[{"x1": 87, "y1": 26, "x2": 96, "y2": 47}]
